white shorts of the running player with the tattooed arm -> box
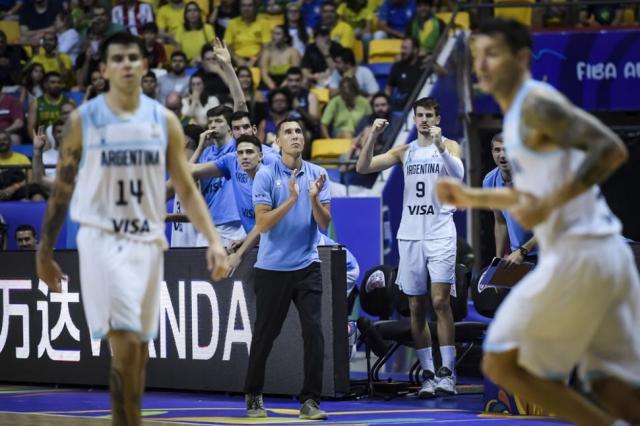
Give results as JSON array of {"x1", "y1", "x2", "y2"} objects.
[{"x1": 484, "y1": 236, "x2": 640, "y2": 390}]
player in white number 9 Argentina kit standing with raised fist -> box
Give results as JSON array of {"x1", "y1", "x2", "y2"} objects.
[{"x1": 356, "y1": 98, "x2": 464, "y2": 398}]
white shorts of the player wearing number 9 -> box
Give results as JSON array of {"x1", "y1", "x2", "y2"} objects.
[{"x1": 396, "y1": 236, "x2": 456, "y2": 296}]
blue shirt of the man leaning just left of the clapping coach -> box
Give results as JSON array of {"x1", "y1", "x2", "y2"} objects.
[{"x1": 214, "y1": 150, "x2": 280, "y2": 234}]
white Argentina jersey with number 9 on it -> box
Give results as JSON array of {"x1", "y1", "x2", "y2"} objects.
[{"x1": 398, "y1": 138, "x2": 456, "y2": 240}]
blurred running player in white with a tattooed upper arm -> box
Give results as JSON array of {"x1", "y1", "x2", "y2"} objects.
[{"x1": 438, "y1": 19, "x2": 640, "y2": 425}]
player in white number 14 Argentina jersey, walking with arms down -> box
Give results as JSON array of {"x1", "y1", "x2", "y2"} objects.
[{"x1": 36, "y1": 33, "x2": 227, "y2": 425}]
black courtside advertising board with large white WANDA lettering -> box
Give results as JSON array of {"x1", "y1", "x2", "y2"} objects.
[{"x1": 0, "y1": 247, "x2": 349, "y2": 396}]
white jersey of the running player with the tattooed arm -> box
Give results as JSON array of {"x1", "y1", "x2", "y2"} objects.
[{"x1": 503, "y1": 80, "x2": 621, "y2": 249}]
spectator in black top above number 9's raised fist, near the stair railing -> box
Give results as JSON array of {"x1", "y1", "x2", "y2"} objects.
[{"x1": 385, "y1": 37, "x2": 424, "y2": 111}]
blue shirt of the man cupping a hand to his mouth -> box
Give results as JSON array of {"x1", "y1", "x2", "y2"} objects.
[{"x1": 198, "y1": 139, "x2": 240, "y2": 225}]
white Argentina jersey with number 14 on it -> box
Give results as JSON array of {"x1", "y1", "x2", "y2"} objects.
[{"x1": 71, "y1": 94, "x2": 167, "y2": 248}]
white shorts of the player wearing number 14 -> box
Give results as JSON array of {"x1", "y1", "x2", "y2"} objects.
[{"x1": 78, "y1": 226, "x2": 164, "y2": 341}]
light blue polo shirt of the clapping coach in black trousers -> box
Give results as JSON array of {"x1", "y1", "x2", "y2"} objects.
[{"x1": 253, "y1": 159, "x2": 331, "y2": 271}]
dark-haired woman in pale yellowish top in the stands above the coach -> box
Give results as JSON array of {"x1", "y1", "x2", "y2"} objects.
[{"x1": 260, "y1": 25, "x2": 300, "y2": 90}]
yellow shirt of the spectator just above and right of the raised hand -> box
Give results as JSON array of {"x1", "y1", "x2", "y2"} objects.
[{"x1": 224, "y1": 16, "x2": 271, "y2": 58}]
